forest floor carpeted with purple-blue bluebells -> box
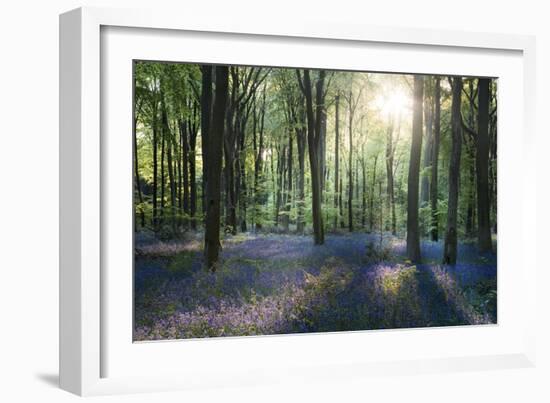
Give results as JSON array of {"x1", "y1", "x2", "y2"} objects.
[{"x1": 134, "y1": 232, "x2": 497, "y2": 340}]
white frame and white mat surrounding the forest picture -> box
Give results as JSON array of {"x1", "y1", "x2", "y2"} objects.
[{"x1": 60, "y1": 8, "x2": 537, "y2": 395}]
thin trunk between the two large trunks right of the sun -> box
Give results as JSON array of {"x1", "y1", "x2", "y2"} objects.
[{"x1": 430, "y1": 77, "x2": 441, "y2": 242}]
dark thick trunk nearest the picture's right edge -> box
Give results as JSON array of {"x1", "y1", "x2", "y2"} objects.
[{"x1": 476, "y1": 78, "x2": 493, "y2": 252}]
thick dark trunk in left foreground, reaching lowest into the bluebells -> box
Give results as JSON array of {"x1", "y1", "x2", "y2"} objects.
[{"x1": 204, "y1": 66, "x2": 228, "y2": 271}]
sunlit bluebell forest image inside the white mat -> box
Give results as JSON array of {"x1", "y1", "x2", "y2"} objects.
[{"x1": 132, "y1": 61, "x2": 498, "y2": 341}]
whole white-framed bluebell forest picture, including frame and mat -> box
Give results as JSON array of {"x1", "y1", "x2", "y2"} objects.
[{"x1": 60, "y1": 8, "x2": 536, "y2": 395}]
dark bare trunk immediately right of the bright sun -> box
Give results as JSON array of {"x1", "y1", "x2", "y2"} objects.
[{"x1": 407, "y1": 75, "x2": 424, "y2": 263}]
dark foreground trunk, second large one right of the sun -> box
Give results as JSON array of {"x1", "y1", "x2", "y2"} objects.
[{"x1": 443, "y1": 77, "x2": 462, "y2": 265}]
